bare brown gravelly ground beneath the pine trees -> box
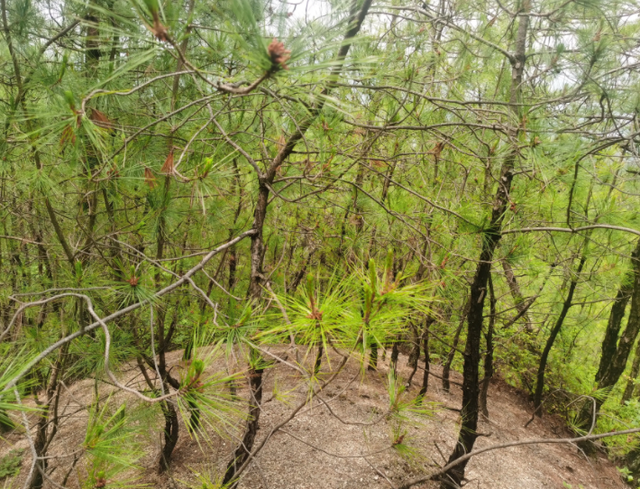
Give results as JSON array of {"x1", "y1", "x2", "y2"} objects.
[{"x1": 0, "y1": 348, "x2": 628, "y2": 489}]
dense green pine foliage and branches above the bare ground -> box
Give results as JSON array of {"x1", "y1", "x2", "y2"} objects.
[{"x1": 0, "y1": 0, "x2": 640, "y2": 480}]
